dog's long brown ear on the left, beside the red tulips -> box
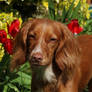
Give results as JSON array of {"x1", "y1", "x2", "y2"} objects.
[{"x1": 10, "y1": 20, "x2": 33, "y2": 71}]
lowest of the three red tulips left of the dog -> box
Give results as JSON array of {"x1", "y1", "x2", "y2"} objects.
[{"x1": 4, "y1": 39, "x2": 13, "y2": 54}]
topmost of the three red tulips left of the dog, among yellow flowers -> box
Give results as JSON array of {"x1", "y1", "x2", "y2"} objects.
[{"x1": 7, "y1": 19, "x2": 20, "y2": 38}]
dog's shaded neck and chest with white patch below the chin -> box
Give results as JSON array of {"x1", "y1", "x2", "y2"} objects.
[{"x1": 32, "y1": 64, "x2": 57, "y2": 92}]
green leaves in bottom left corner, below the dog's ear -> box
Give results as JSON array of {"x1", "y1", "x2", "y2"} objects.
[{"x1": 0, "y1": 54, "x2": 31, "y2": 92}]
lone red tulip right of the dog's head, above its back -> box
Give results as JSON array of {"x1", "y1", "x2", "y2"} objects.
[{"x1": 67, "y1": 19, "x2": 83, "y2": 34}]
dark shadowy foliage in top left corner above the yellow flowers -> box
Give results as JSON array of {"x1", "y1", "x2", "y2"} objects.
[{"x1": 0, "y1": 0, "x2": 40, "y2": 20}]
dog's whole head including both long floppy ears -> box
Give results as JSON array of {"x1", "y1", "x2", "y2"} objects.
[{"x1": 11, "y1": 19, "x2": 79, "y2": 70}]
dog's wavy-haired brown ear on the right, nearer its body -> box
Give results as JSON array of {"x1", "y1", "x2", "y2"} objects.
[{"x1": 55, "y1": 23, "x2": 80, "y2": 73}]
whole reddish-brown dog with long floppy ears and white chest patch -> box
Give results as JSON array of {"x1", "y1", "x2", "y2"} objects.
[{"x1": 11, "y1": 19, "x2": 92, "y2": 92}]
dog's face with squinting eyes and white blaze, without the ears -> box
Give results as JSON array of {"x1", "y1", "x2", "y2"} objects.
[{"x1": 27, "y1": 22, "x2": 61, "y2": 66}]
